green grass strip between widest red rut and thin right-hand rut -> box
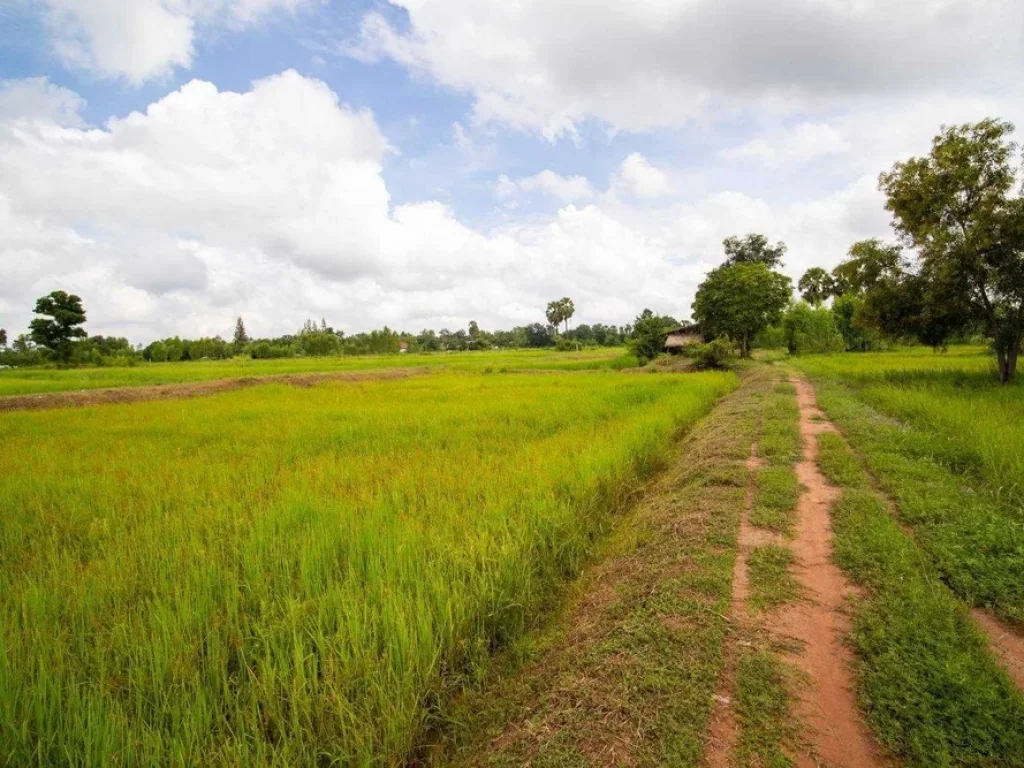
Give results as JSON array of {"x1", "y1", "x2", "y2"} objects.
[{"x1": 818, "y1": 436, "x2": 1024, "y2": 767}]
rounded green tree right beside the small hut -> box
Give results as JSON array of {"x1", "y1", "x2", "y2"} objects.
[{"x1": 693, "y1": 262, "x2": 793, "y2": 357}]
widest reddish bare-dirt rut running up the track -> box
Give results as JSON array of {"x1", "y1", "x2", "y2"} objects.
[{"x1": 769, "y1": 380, "x2": 886, "y2": 768}]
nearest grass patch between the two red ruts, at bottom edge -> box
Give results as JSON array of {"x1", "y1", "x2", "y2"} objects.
[{"x1": 736, "y1": 649, "x2": 800, "y2": 768}]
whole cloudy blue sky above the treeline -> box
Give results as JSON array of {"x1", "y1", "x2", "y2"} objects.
[{"x1": 0, "y1": 0, "x2": 1024, "y2": 343}]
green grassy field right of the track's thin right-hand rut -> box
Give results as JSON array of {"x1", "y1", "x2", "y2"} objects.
[{"x1": 793, "y1": 347, "x2": 1024, "y2": 625}]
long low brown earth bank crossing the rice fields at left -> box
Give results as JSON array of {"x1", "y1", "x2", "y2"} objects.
[{"x1": 0, "y1": 368, "x2": 430, "y2": 412}]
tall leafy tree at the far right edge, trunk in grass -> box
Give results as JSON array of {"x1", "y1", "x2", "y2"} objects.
[{"x1": 879, "y1": 120, "x2": 1024, "y2": 383}]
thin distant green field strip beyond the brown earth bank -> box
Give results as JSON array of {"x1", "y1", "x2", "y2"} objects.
[{"x1": 0, "y1": 348, "x2": 636, "y2": 396}]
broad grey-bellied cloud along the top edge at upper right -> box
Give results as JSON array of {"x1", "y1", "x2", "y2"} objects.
[{"x1": 347, "y1": 0, "x2": 1024, "y2": 139}]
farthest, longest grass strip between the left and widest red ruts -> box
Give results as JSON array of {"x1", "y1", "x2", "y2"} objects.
[{"x1": 751, "y1": 381, "x2": 801, "y2": 535}]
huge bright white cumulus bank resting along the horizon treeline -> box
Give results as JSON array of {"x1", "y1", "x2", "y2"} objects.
[{"x1": 0, "y1": 71, "x2": 1013, "y2": 341}]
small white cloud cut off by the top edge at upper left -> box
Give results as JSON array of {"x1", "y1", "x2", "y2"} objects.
[{"x1": 42, "y1": 0, "x2": 307, "y2": 85}]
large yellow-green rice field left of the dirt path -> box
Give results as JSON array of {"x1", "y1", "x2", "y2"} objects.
[{"x1": 0, "y1": 374, "x2": 735, "y2": 766}]
